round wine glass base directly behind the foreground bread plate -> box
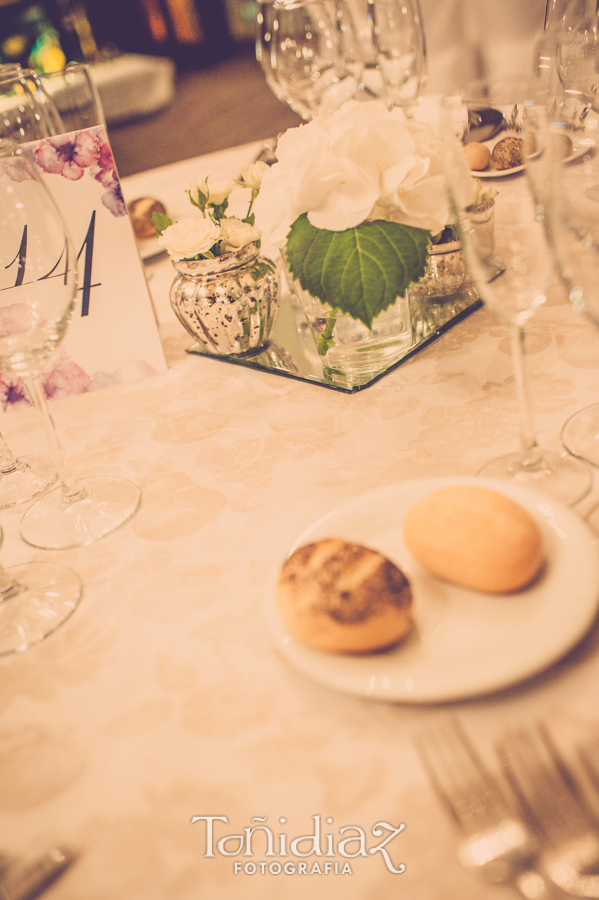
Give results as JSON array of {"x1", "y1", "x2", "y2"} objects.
[{"x1": 477, "y1": 450, "x2": 593, "y2": 506}]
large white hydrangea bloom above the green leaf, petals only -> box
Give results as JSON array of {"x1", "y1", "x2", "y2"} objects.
[{"x1": 254, "y1": 101, "x2": 449, "y2": 246}]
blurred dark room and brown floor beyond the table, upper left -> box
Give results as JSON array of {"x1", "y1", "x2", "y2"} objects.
[{"x1": 0, "y1": 0, "x2": 300, "y2": 177}]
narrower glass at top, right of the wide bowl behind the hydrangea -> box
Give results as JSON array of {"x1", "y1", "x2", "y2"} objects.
[{"x1": 368, "y1": 0, "x2": 427, "y2": 112}]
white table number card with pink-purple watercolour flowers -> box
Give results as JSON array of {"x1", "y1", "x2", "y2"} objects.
[{"x1": 0, "y1": 126, "x2": 166, "y2": 407}]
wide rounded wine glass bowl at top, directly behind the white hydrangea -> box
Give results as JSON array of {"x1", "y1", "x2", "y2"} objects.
[{"x1": 260, "y1": 0, "x2": 363, "y2": 119}]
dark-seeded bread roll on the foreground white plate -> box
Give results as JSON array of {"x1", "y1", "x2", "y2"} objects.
[{"x1": 277, "y1": 538, "x2": 413, "y2": 653}]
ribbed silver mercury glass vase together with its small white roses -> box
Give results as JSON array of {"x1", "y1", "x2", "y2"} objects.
[{"x1": 152, "y1": 163, "x2": 279, "y2": 356}]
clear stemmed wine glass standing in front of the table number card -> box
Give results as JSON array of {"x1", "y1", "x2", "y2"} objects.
[{"x1": 0, "y1": 141, "x2": 140, "y2": 550}]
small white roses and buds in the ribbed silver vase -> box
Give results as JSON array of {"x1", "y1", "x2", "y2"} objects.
[{"x1": 152, "y1": 162, "x2": 268, "y2": 261}]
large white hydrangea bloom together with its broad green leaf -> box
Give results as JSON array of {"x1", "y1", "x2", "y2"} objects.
[{"x1": 255, "y1": 101, "x2": 449, "y2": 328}]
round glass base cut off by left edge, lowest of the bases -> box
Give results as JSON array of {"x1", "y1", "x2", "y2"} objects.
[{"x1": 0, "y1": 562, "x2": 81, "y2": 655}]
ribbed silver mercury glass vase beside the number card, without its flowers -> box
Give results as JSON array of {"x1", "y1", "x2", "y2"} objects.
[{"x1": 170, "y1": 241, "x2": 279, "y2": 356}]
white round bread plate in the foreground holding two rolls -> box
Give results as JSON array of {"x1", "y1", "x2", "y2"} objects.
[{"x1": 267, "y1": 477, "x2": 599, "y2": 703}]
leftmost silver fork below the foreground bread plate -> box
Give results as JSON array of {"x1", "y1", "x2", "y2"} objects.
[{"x1": 414, "y1": 719, "x2": 554, "y2": 900}]
